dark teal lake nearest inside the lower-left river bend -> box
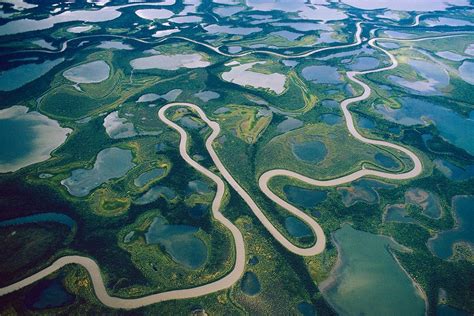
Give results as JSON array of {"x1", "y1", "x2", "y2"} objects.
[{"x1": 145, "y1": 217, "x2": 207, "y2": 269}]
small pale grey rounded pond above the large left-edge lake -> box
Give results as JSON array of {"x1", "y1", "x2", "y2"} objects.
[{"x1": 63, "y1": 60, "x2": 110, "y2": 83}]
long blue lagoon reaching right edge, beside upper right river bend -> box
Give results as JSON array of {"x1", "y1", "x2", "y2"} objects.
[{"x1": 376, "y1": 98, "x2": 474, "y2": 155}]
